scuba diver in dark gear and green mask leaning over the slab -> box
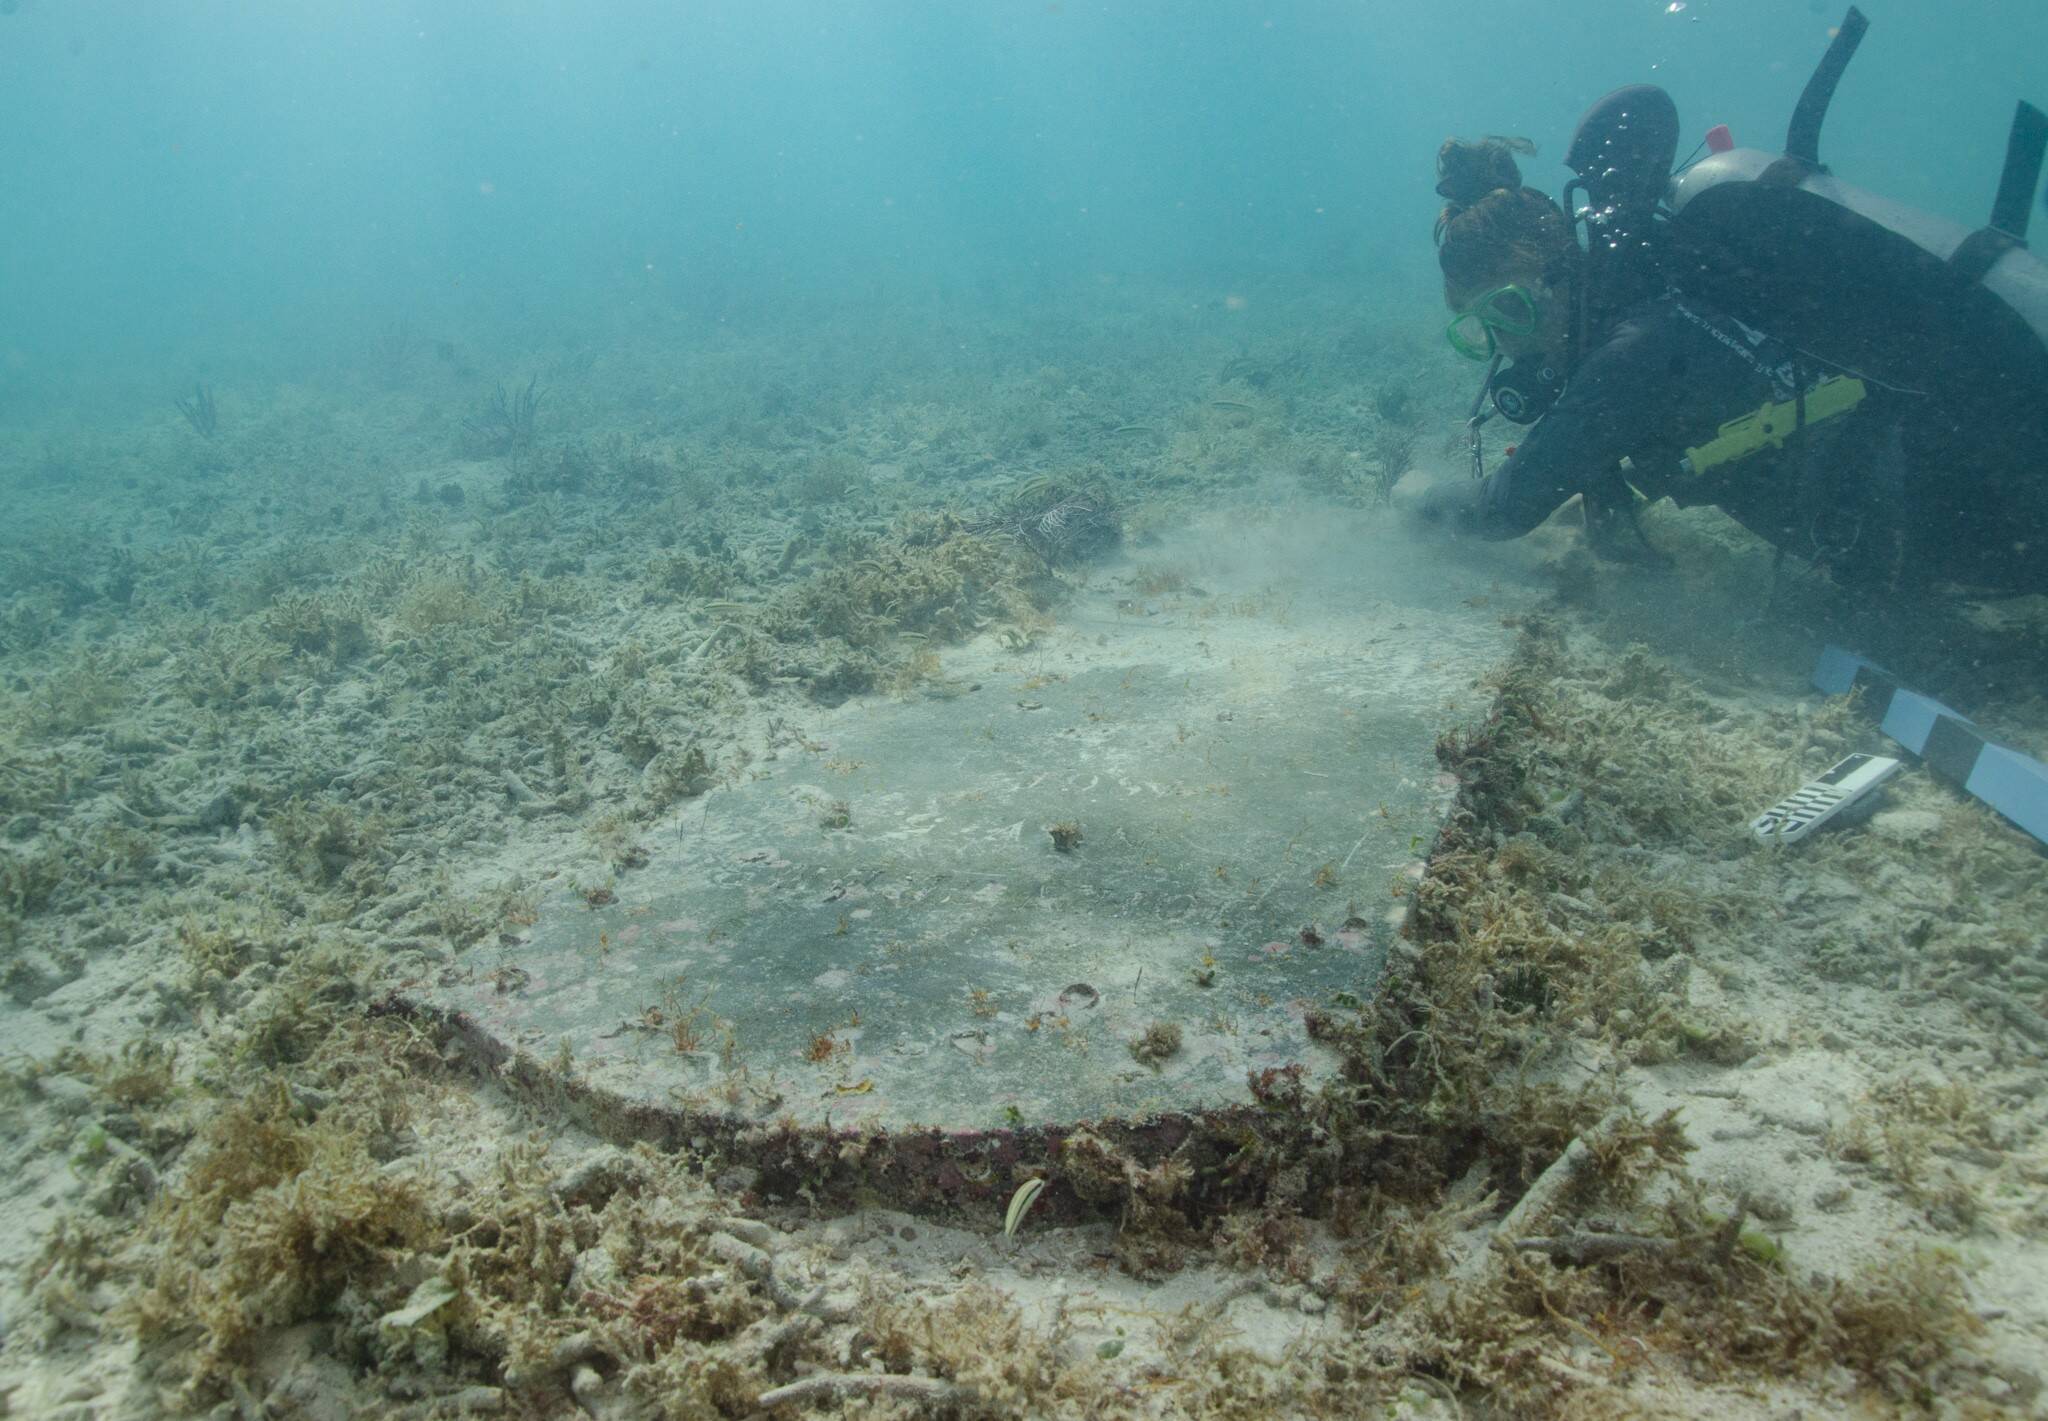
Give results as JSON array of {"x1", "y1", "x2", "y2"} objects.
[{"x1": 1419, "y1": 8, "x2": 2048, "y2": 594}]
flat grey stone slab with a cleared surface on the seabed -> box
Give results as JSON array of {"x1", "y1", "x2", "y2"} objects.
[{"x1": 414, "y1": 528, "x2": 1503, "y2": 1132}]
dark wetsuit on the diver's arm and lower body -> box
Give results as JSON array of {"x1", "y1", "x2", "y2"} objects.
[{"x1": 1434, "y1": 293, "x2": 2048, "y2": 592}]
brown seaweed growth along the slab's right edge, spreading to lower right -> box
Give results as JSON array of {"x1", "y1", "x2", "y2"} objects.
[{"x1": 1277, "y1": 620, "x2": 1978, "y2": 1415}]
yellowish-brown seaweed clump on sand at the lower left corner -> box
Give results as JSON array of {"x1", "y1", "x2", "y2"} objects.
[{"x1": 64, "y1": 1016, "x2": 798, "y2": 1417}]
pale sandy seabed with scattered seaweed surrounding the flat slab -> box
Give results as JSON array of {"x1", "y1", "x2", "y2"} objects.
[{"x1": 0, "y1": 287, "x2": 2048, "y2": 1419}]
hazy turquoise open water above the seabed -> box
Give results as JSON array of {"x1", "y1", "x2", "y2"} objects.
[{"x1": 0, "y1": 0, "x2": 2048, "y2": 401}]
